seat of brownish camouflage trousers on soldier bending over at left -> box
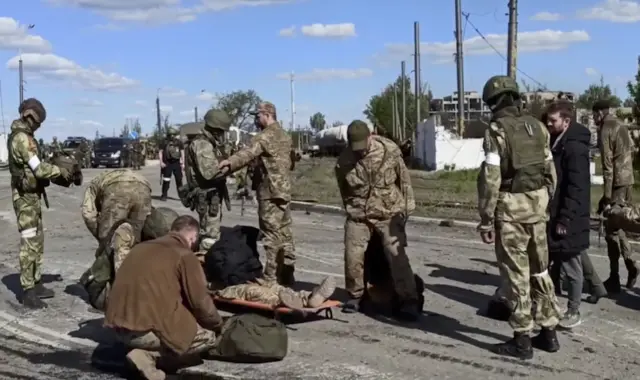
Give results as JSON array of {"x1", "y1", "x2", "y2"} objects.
[{"x1": 98, "y1": 182, "x2": 151, "y2": 240}]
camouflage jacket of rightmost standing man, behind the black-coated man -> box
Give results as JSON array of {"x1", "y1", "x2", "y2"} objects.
[{"x1": 598, "y1": 115, "x2": 634, "y2": 199}]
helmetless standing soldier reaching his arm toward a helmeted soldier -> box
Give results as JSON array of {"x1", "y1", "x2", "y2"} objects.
[{"x1": 218, "y1": 102, "x2": 296, "y2": 286}]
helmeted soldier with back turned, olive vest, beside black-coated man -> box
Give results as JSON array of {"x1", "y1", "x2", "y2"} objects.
[{"x1": 478, "y1": 75, "x2": 560, "y2": 359}]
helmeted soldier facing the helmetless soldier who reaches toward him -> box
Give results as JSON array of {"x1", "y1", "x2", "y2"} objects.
[{"x1": 180, "y1": 109, "x2": 231, "y2": 252}]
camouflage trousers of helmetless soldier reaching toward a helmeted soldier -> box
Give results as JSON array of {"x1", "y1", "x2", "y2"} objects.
[{"x1": 258, "y1": 199, "x2": 296, "y2": 281}]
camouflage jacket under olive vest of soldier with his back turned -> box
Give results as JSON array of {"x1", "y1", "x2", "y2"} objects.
[{"x1": 477, "y1": 107, "x2": 557, "y2": 231}]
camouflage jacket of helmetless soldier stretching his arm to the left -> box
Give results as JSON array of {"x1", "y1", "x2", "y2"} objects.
[{"x1": 229, "y1": 123, "x2": 291, "y2": 201}]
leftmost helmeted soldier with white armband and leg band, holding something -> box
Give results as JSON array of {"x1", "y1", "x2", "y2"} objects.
[{"x1": 7, "y1": 98, "x2": 72, "y2": 309}]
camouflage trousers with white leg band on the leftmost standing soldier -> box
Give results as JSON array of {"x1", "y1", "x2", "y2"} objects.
[{"x1": 12, "y1": 190, "x2": 44, "y2": 290}]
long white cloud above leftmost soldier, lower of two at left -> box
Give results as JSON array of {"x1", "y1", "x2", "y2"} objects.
[{"x1": 7, "y1": 53, "x2": 139, "y2": 91}]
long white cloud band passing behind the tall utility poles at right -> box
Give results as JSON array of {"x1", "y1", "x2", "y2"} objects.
[{"x1": 376, "y1": 29, "x2": 591, "y2": 63}]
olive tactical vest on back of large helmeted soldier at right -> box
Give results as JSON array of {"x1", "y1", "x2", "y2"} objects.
[{"x1": 493, "y1": 115, "x2": 547, "y2": 193}]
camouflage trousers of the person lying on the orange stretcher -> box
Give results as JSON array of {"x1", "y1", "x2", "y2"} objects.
[{"x1": 216, "y1": 283, "x2": 311, "y2": 307}]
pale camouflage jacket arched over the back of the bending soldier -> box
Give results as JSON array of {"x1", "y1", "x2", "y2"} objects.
[{"x1": 82, "y1": 169, "x2": 151, "y2": 238}]
